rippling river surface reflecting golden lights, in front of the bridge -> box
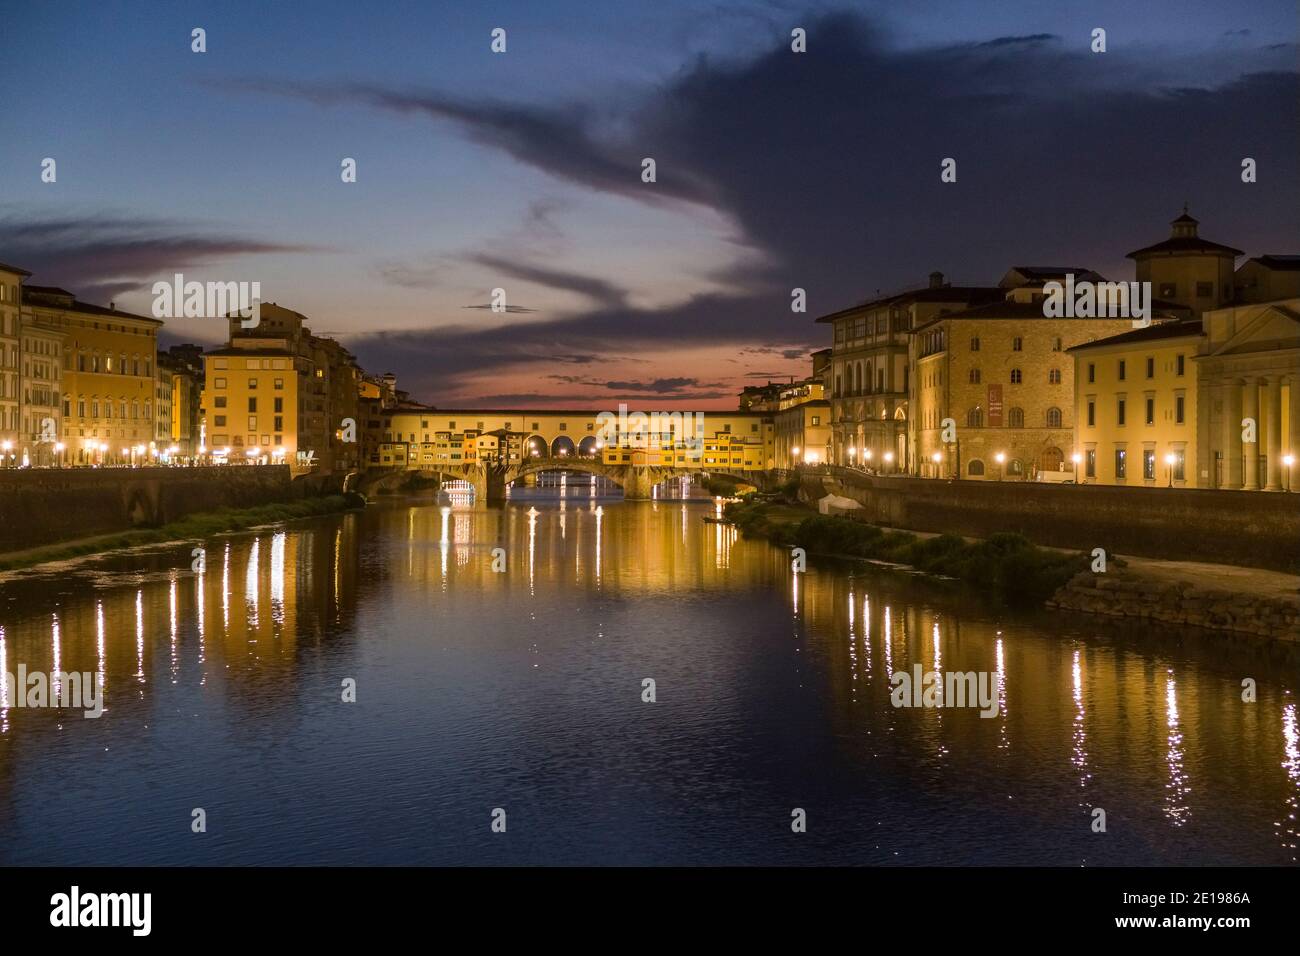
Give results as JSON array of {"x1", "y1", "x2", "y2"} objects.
[{"x1": 0, "y1": 496, "x2": 1300, "y2": 866}]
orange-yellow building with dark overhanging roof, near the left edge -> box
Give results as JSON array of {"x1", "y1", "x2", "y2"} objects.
[{"x1": 23, "y1": 285, "x2": 163, "y2": 464}]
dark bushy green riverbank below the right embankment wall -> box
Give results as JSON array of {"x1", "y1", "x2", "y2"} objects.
[{"x1": 725, "y1": 502, "x2": 1089, "y2": 605}]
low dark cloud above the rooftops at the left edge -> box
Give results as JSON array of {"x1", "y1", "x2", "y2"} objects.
[{"x1": 0, "y1": 209, "x2": 321, "y2": 302}]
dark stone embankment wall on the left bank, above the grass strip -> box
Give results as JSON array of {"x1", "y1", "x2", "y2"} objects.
[{"x1": 0, "y1": 466, "x2": 299, "y2": 553}]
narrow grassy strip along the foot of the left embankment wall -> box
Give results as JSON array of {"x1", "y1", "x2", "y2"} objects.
[{"x1": 0, "y1": 494, "x2": 360, "y2": 571}]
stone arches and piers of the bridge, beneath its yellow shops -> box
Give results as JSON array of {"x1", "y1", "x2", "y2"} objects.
[{"x1": 356, "y1": 457, "x2": 767, "y2": 503}]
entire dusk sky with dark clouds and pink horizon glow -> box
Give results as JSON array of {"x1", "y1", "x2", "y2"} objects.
[{"x1": 0, "y1": 0, "x2": 1300, "y2": 408}]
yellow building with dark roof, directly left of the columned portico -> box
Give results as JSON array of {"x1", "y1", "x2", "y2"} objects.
[{"x1": 1070, "y1": 320, "x2": 1205, "y2": 488}]
